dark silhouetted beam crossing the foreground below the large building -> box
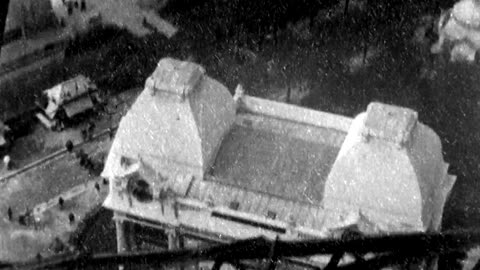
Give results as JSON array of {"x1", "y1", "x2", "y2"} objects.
[{"x1": 0, "y1": 231, "x2": 480, "y2": 270}]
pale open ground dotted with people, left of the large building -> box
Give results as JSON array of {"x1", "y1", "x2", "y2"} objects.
[{"x1": 0, "y1": 89, "x2": 138, "y2": 261}]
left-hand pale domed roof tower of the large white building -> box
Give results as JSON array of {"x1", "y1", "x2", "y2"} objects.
[{"x1": 103, "y1": 58, "x2": 234, "y2": 180}]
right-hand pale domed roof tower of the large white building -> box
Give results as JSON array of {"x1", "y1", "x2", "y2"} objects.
[{"x1": 324, "y1": 103, "x2": 455, "y2": 230}]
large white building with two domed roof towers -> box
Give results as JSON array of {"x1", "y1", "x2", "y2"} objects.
[{"x1": 103, "y1": 58, "x2": 455, "y2": 266}]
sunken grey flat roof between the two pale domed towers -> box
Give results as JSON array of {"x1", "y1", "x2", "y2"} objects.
[{"x1": 207, "y1": 114, "x2": 346, "y2": 203}]
